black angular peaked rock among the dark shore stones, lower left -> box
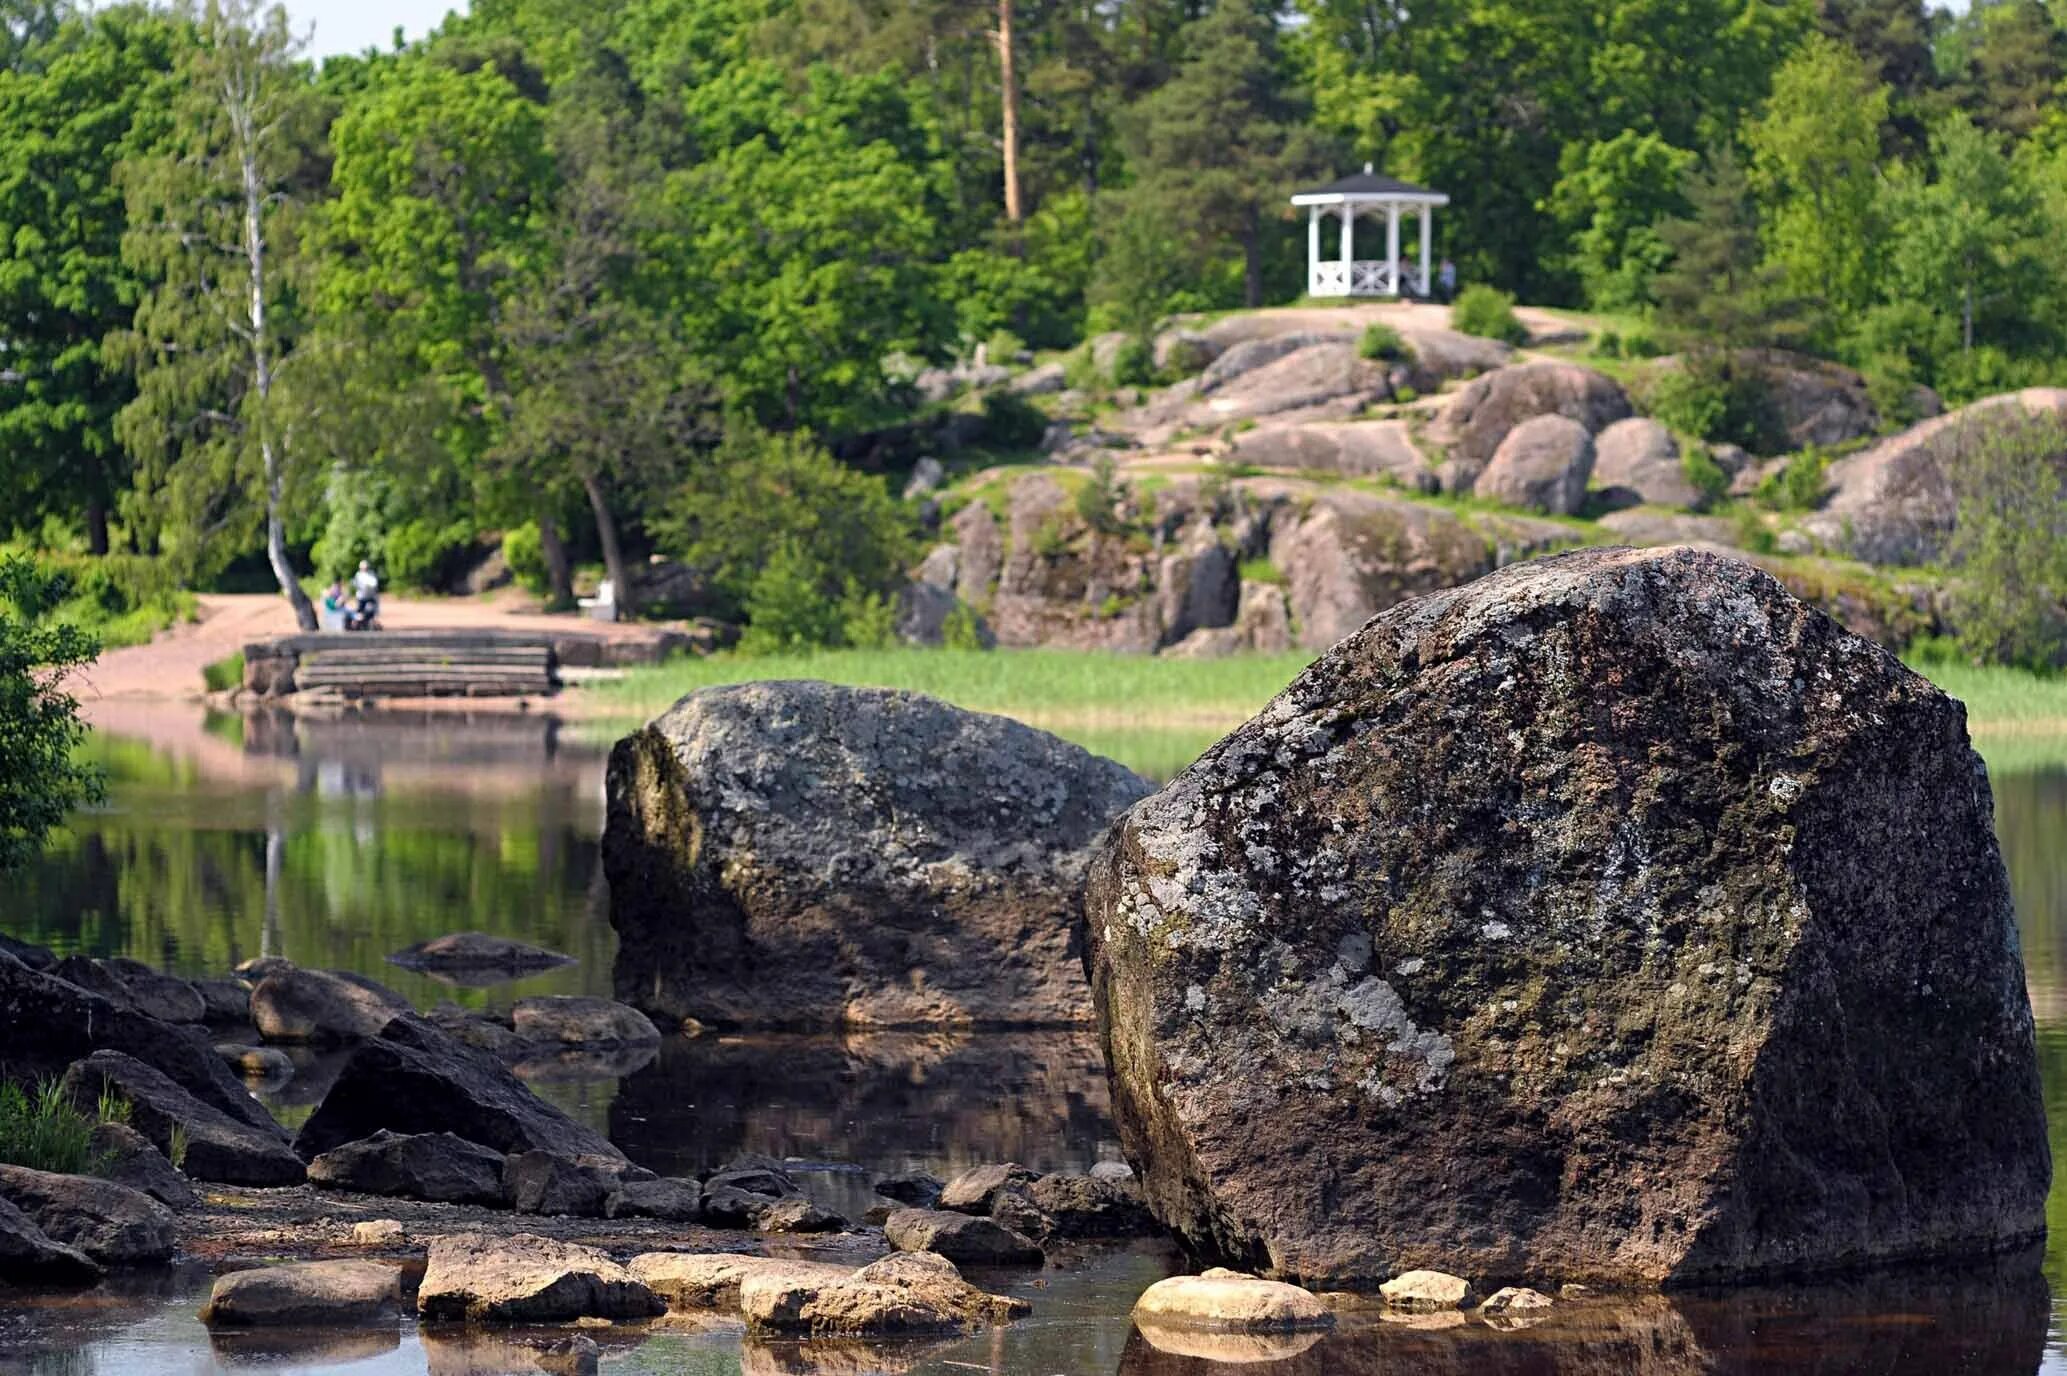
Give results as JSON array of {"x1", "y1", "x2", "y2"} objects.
[{"x1": 294, "y1": 1017, "x2": 624, "y2": 1161}]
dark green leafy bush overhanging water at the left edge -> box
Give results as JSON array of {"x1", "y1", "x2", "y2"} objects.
[{"x1": 0, "y1": 552, "x2": 99, "y2": 874}]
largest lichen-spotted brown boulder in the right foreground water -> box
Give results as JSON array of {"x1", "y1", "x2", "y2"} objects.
[{"x1": 1085, "y1": 550, "x2": 2050, "y2": 1285}]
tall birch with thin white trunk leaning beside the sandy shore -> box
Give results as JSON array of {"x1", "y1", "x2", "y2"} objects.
[{"x1": 114, "y1": 0, "x2": 320, "y2": 630}]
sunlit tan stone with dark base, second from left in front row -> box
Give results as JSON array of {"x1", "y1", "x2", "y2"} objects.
[{"x1": 415, "y1": 1233, "x2": 668, "y2": 1324}]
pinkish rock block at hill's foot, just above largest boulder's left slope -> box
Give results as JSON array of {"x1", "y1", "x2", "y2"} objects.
[{"x1": 1271, "y1": 488, "x2": 1494, "y2": 649}]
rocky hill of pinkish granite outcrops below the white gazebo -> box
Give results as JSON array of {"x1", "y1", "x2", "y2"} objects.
[{"x1": 903, "y1": 304, "x2": 2067, "y2": 655}]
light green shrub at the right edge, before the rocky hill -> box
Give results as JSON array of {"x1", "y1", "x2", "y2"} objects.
[{"x1": 1947, "y1": 419, "x2": 2067, "y2": 669}]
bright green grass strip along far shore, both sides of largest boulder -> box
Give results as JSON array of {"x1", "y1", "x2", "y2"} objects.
[{"x1": 583, "y1": 649, "x2": 2067, "y2": 779}]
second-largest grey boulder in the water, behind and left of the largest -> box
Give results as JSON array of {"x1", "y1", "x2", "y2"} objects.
[{"x1": 604, "y1": 682, "x2": 1147, "y2": 1027}]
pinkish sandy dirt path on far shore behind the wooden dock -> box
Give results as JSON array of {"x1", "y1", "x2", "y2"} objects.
[{"x1": 72, "y1": 593, "x2": 669, "y2": 717}]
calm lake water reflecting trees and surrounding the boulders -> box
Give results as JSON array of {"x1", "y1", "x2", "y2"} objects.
[{"x1": 12, "y1": 709, "x2": 2067, "y2": 1376}]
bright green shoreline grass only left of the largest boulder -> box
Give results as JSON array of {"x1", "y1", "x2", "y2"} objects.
[{"x1": 583, "y1": 649, "x2": 1310, "y2": 779}]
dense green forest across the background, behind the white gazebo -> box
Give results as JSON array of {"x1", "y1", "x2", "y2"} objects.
[{"x1": 0, "y1": 0, "x2": 2067, "y2": 640}]
